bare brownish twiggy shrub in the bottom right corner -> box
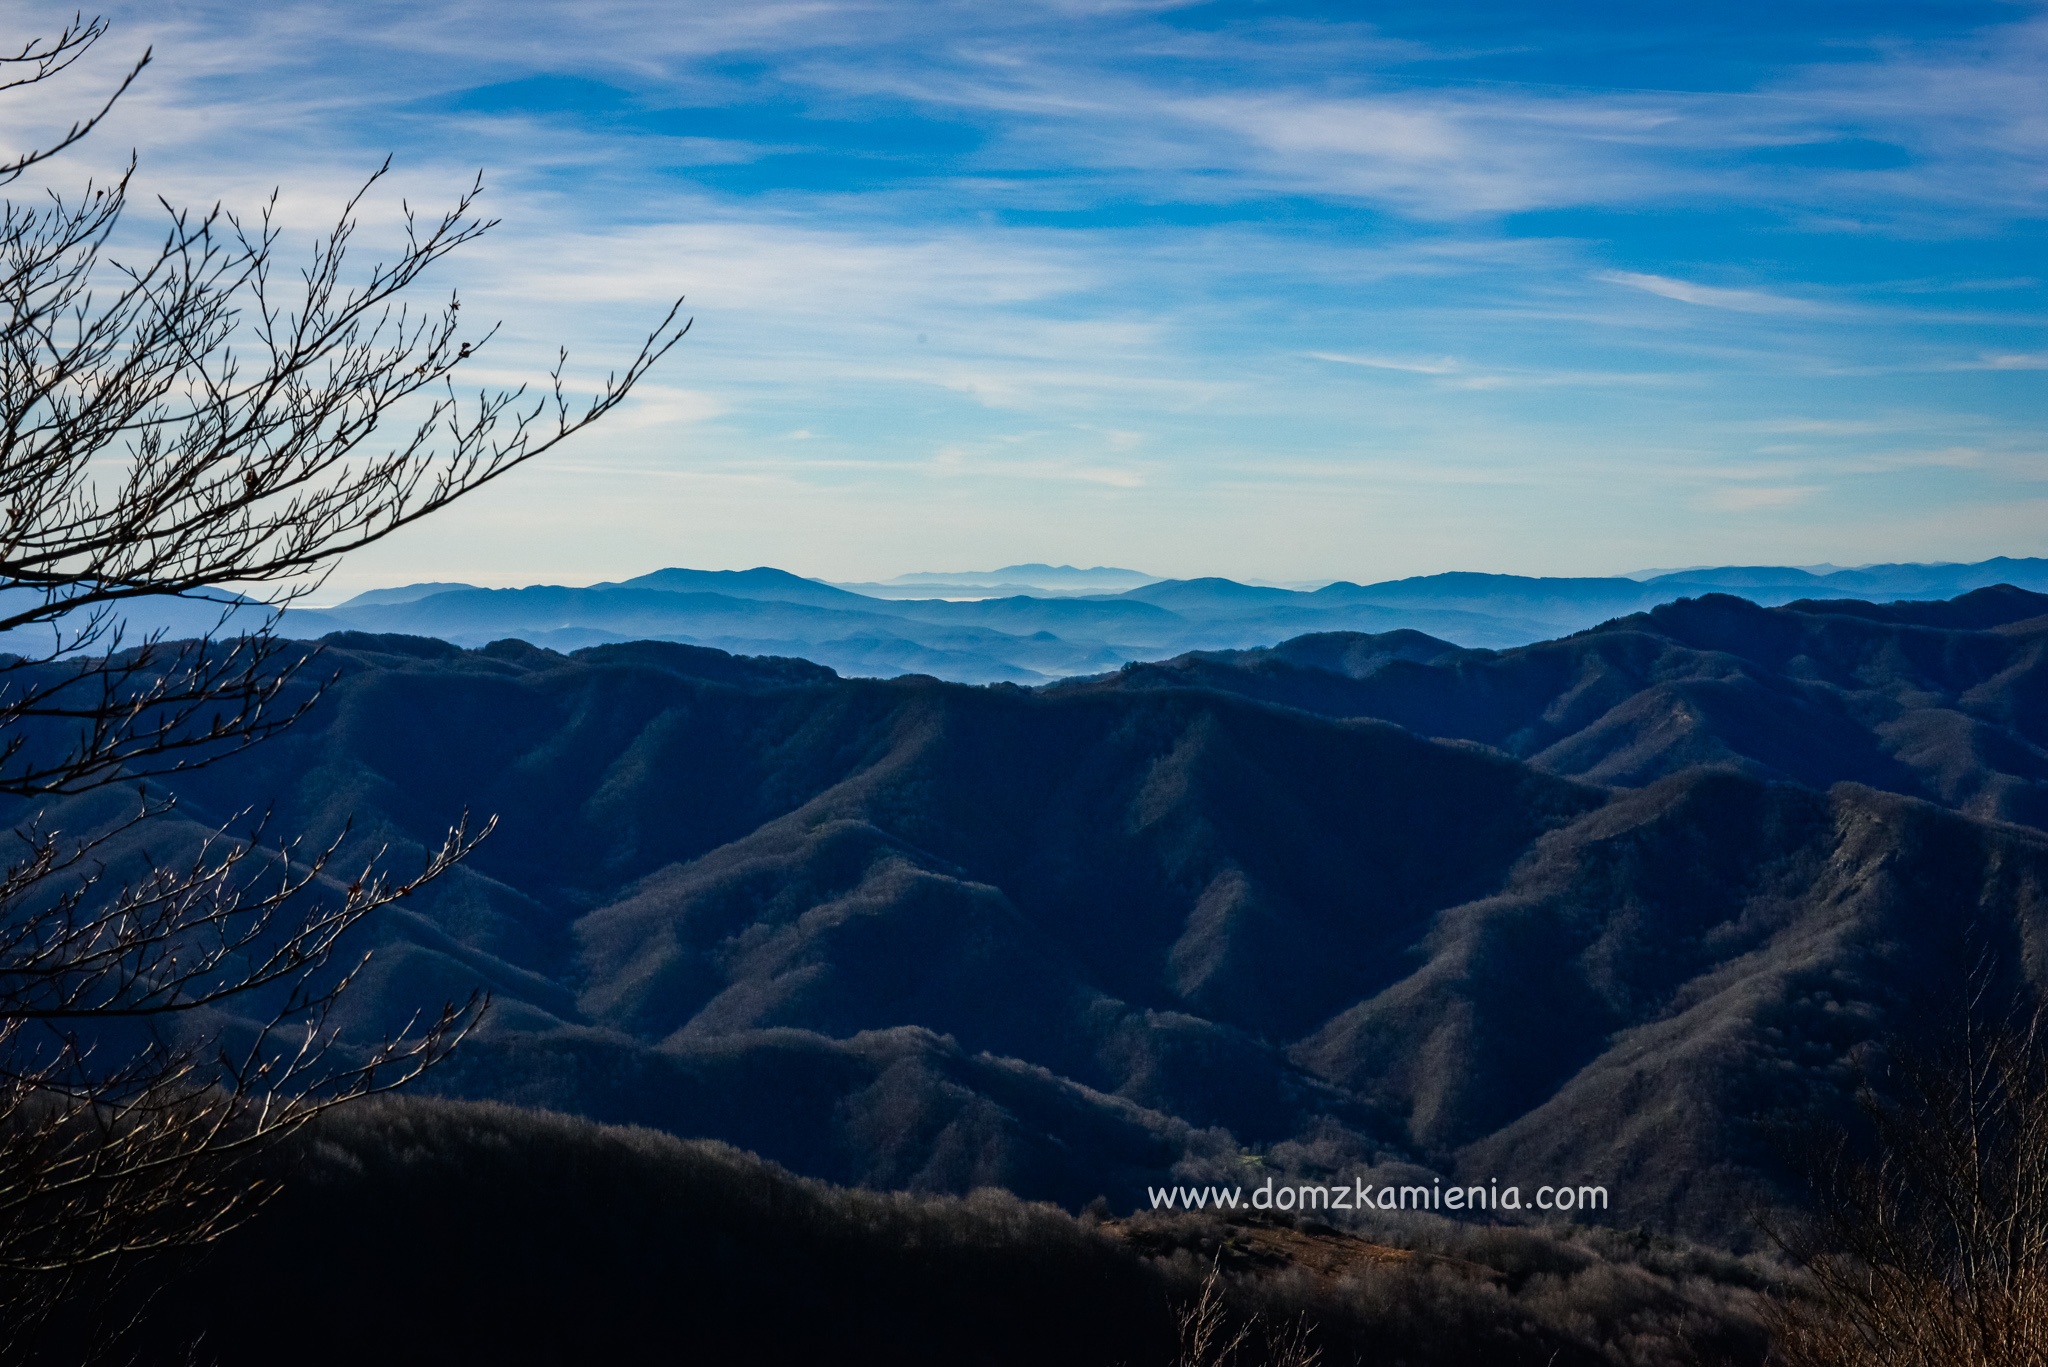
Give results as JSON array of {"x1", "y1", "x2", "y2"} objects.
[{"x1": 1772, "y1": 992, "x2": 2048, "y2": 1367}]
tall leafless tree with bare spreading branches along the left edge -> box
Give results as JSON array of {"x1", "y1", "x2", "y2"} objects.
[{"x1": 0, "y1": 18, "x2": 688, "y2": 1357}]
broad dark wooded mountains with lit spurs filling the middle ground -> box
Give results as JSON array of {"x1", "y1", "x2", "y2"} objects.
[{"x1": 16, "y1": 576, "x2": 2048, "y2": 1240}]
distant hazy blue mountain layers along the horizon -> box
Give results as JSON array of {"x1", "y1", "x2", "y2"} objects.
[{"x1": 272, "y1": 557, "x2": 2048, "y2": 685}]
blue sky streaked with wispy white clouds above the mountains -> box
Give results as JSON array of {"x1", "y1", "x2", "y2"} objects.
[{"x1": 0, "y1": 0, "x2": 2048, "y2": 596}]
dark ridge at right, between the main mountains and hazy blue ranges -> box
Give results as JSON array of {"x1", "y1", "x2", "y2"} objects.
[{"x1": 1059, "y1": 584, "x2": 2048, "y2": 828}]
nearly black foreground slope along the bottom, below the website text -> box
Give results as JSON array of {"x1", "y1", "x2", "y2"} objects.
[{"x1": 116, "y1": 1103, "x2": 1763, "y2": 1367}]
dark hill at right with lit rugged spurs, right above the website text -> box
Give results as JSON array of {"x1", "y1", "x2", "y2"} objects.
[{"x1": 1292, "y1": 771, "x2": 2048, "y2": 1228}]
